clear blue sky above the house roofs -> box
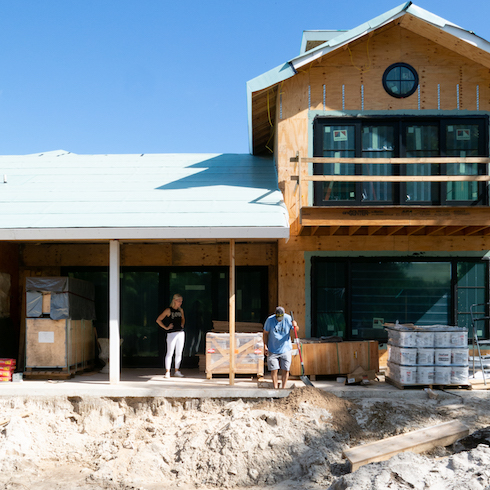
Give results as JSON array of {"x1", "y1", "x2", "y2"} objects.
[{"x1": 0, "y1": 0, "x2": 490, "y2": 155}]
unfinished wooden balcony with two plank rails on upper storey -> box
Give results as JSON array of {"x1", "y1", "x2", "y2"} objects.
[{"x1": 290, "y1": 154, "x2": 490, "y2": 236}]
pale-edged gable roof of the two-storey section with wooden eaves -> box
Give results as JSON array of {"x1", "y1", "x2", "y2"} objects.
[{"x1": 247, "y1": 2, "x2": 490, "y2": 155}]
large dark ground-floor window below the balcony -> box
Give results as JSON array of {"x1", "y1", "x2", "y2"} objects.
[{"x1": 312, "y1": 257, "x2": 488, "y2": 340}]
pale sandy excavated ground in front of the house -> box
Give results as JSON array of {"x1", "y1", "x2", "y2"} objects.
[{"x1": 0, "y1": 386, "x2": 490, "y2": 490}]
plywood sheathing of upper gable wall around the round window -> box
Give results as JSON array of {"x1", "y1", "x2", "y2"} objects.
[{"x1": 277, "y1": 23, "x2": 490, "y2": 235}]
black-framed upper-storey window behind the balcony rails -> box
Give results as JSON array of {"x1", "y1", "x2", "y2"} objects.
[{"x1": 313, "y1": 117, "x2": 488, "y2": 206}]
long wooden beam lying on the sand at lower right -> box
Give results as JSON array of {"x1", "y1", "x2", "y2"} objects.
[{"x1": 343, "y1": 420, "x2": 469, "y2": 471}]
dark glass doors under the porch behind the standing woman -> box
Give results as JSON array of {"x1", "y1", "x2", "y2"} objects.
[{"x1": 62, "y1": 267, "x2": 270, "y2": 367}]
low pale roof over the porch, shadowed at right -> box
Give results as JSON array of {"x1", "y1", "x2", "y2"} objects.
[{"x1": 0, "y1": 150, "x2": 289, "y2": 240}]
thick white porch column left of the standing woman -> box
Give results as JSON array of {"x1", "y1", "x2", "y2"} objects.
[{"x1": 109, "y1": 240, "x2": 121, "y2": 384}]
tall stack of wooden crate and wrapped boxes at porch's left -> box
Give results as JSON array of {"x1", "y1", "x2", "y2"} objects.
[{"x1": 25, "y1": 277, "x2": 95, "y2": 378}]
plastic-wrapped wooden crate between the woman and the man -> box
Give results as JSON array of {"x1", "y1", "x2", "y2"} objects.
[{"x1": 206, "y1": 332, "x2": 264, "y2": 379}]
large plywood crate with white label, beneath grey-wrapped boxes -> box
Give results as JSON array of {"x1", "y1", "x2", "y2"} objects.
[{"x1": 25, "y1": 318, "x2": 95, "y2": 377}]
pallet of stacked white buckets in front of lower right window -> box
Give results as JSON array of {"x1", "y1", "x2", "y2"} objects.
[{"x1": 386, "y1": 323, "x2": 469, "y2": 388}]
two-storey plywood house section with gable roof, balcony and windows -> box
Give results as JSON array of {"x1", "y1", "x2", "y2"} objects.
[{"x1": 248, "y1": 2, "x2": 490, "y2": 341}]
